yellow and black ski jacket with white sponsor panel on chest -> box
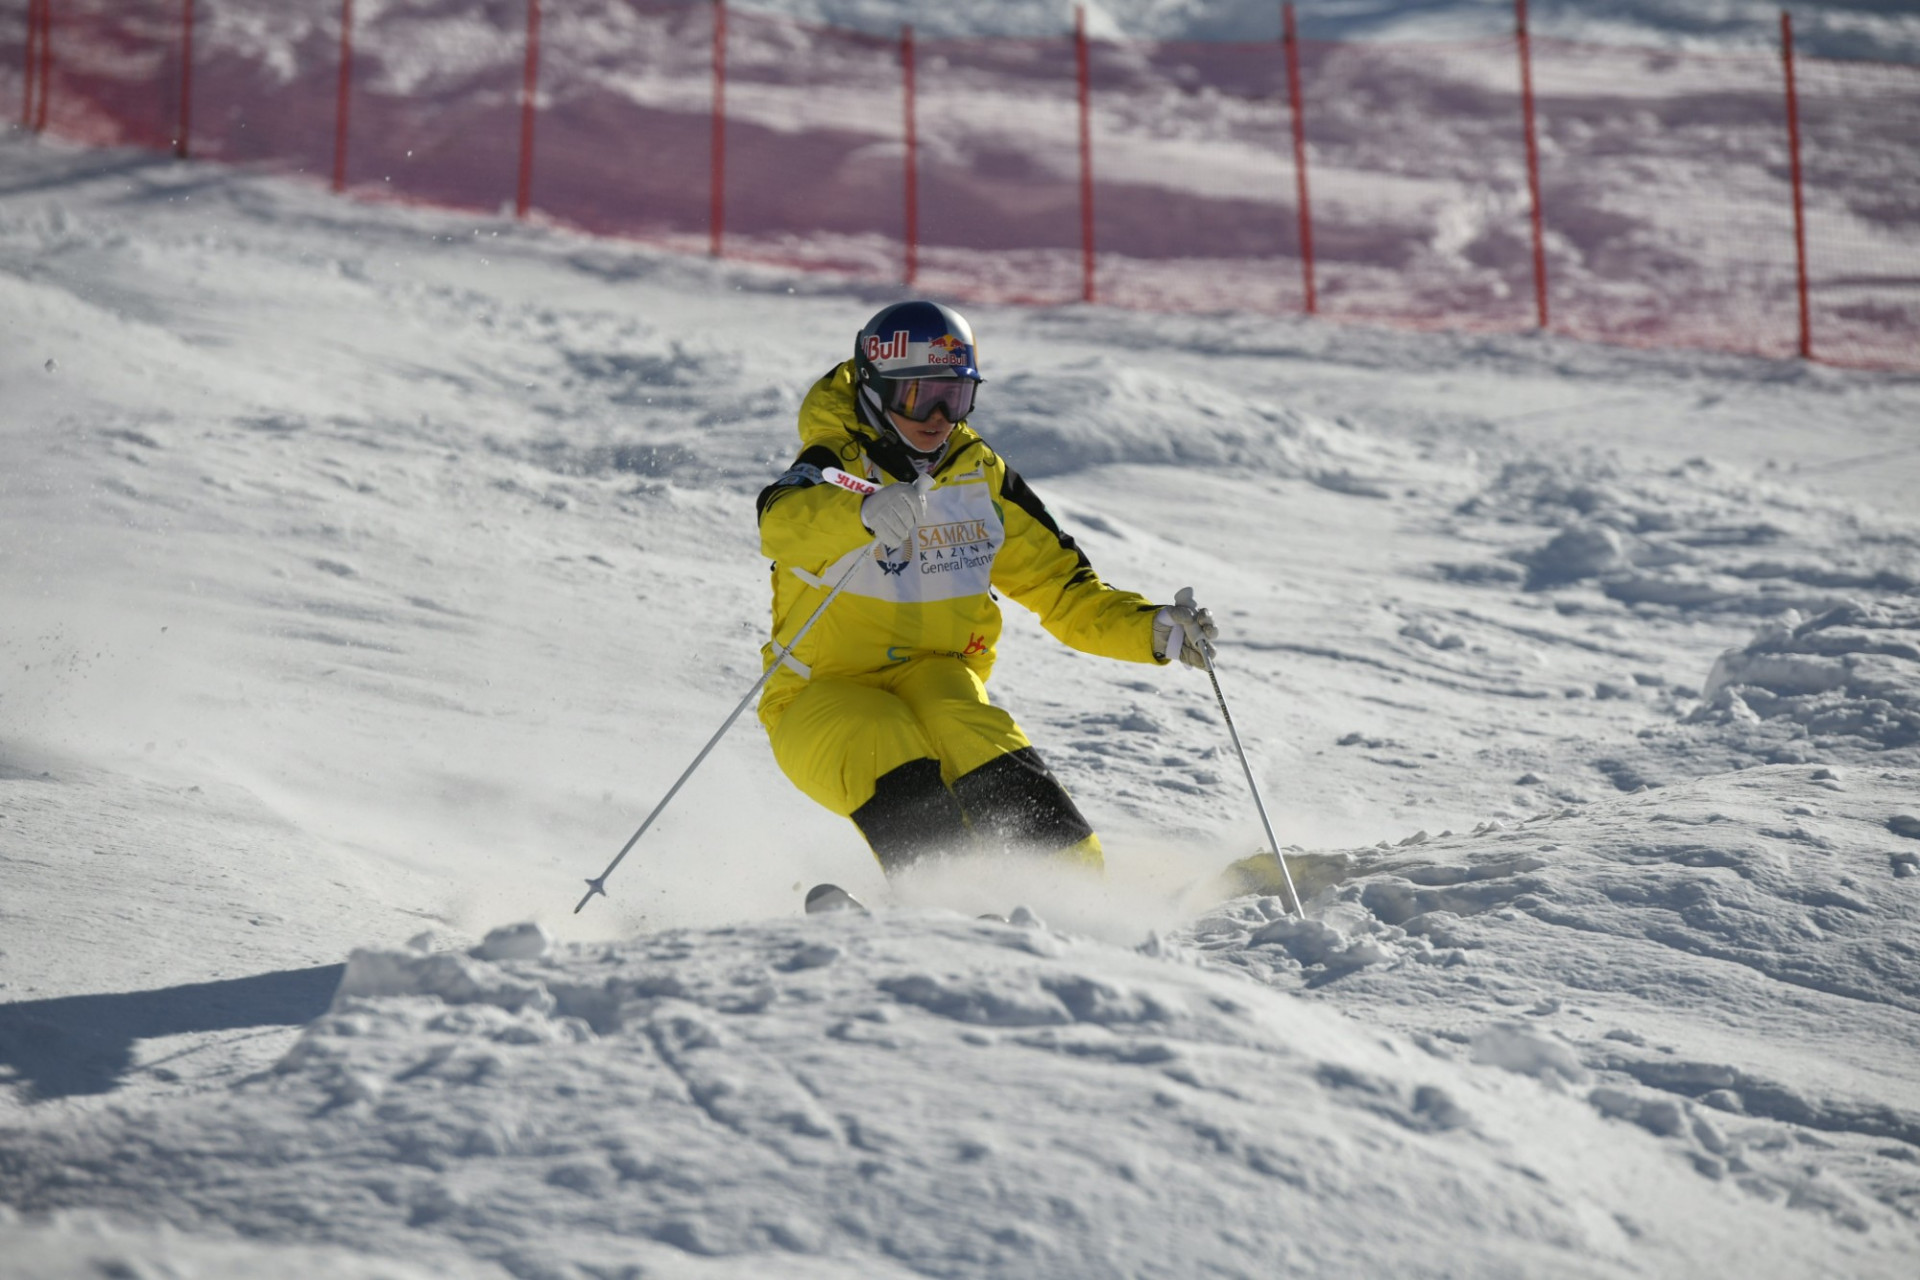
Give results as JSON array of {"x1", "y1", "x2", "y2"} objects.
[{"x1": 758, "y1": 361, "x2": 1164, "y2": 725}]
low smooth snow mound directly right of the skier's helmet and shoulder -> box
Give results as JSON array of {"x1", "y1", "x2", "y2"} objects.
[{"x1": 975, "y1": 357, "x2": 1384, "y2": 497}]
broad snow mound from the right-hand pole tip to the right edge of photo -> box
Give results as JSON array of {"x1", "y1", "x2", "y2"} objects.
[{"x1": 1183, "y1": 766, "x2": 1920, "y2": 1020}]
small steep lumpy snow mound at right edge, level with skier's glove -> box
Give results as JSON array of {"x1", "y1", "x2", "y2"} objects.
[{"x1": 1690, "y1": 599, "x2": 1920, "y2": 750}]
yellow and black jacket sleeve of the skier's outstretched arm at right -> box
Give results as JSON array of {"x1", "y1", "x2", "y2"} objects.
[{"x1": 993, "y1": 462, "x2": 1162, "y2": 664}]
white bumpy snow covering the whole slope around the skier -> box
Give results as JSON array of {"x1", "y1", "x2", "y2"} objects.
[{"x1": 0, "y1": 2, "x2": 1920, "y2": 1278}]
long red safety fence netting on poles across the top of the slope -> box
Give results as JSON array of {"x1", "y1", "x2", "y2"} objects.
[{"x1": 0, "y1": 0, "x2": 1920, "y2": 368}]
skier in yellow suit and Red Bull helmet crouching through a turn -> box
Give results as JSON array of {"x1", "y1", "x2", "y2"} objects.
[{"x1": 758, "y1": 301, "x2": 1217, "y2": 875}]
